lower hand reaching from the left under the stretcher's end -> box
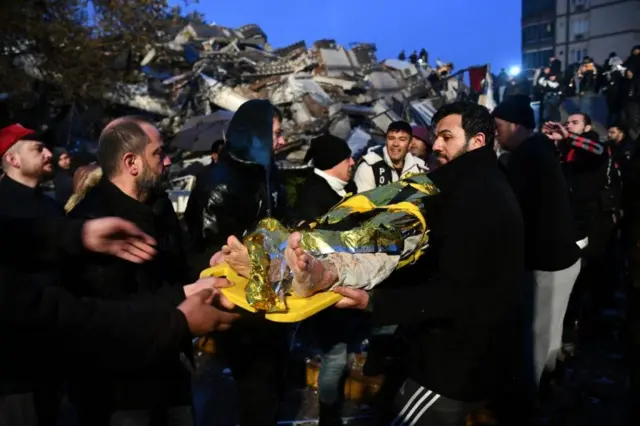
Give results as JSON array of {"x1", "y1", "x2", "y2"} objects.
[{"x1": 178, "y1": 289, "x2": 240, "y2": 336}]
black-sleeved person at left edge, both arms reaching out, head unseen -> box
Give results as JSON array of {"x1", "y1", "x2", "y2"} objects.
[{"x1": 0, "y1": 218, "x2": 240, "y2": 426}]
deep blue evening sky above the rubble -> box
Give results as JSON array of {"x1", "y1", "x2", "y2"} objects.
[{"x1": 175, "y1": 0, "x2": 521, "y2": 73}]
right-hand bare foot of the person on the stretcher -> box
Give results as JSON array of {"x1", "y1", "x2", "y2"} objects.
[{"x1": 284, "y1": 232, "x2": 337, "y2": 297}]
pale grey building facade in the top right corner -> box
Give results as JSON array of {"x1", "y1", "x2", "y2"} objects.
[{"x1": 556, "y1": 0, "x2": 640, "y2": 67}]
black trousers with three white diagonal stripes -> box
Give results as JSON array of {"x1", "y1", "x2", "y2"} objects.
[{"x1": 378, "y1": 379, "x2": 484, "y2": 426}]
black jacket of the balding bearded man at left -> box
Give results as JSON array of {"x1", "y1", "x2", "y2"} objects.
[{"x1": 64, "y1": 178, "x2": 190, "y2": 410}]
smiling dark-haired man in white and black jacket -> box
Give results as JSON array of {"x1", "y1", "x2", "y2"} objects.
[{"x1": 354, "y1": 121, "x2": 427, "y2": 192}]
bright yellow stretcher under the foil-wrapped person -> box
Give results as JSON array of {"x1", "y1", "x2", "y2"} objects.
[{"x1": 200, "y1": 263, "x2": 342, "y2": 323}]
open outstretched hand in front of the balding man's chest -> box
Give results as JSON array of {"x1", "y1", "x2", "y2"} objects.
[{"x1": 82, "y1": 217, "x2": 156, "y2": 263}]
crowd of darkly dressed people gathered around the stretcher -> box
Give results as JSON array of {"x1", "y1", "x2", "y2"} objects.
[{"x1": 0, "y1": 83, "x2": 640, "y2": 426}]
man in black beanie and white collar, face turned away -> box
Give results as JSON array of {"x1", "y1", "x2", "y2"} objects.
[{"x1": 294, "y1": 134, "x2": 362, "y2": 426}]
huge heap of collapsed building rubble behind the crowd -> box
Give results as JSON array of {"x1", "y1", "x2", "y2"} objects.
[{"x1": 12, "y1": 23, "x2": 484, "y2": 167}]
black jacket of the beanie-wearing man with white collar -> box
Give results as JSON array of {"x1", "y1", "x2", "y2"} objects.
[{"x1": 294, "y1": 173, "x2": 357, "y2": 221}]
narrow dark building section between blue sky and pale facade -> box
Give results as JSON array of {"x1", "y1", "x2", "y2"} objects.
[{"x1": 522, "y1": 0, "x2": 563, "y2": 70}]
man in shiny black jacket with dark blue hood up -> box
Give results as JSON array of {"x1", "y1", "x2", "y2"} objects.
[{"x1": 196, "y1": 100, "x2": 290, "y2": 426}]
